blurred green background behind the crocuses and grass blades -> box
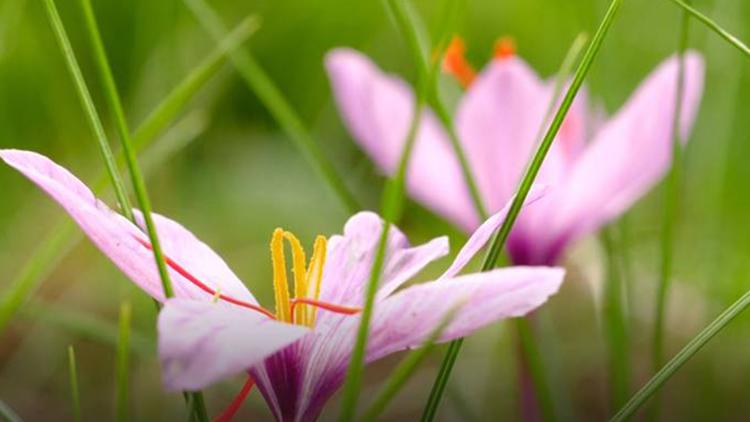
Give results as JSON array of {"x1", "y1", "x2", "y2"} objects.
[{"x1": 0, "y1": 0, "x2": 750, "y2": 420}]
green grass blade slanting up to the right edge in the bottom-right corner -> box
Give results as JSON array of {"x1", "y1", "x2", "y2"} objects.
[{"x1": 610, "y1": 291, "x2": 750, "y2": 422}]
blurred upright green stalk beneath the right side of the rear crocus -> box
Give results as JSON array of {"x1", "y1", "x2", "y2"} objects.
[{"x1": 600, "y1": 228, "x2": 630, "y2": 409}]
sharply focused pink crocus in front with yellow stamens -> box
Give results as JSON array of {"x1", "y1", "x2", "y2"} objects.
[{"x1": 0, "y1": 150, "x2": 564, "y2": 421}]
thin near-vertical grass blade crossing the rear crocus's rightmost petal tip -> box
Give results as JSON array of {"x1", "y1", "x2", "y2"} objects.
[{"x1": 649, "y1": 4, "x2": 690, "y2": 420}]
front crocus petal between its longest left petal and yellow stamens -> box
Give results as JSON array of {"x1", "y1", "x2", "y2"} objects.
[{"x1": 133, "y1": 210, "x2": 258, "y2": 304}]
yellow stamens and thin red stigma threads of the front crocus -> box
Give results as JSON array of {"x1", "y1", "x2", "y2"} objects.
[{"x1": 133, "y1": 229, "x2": 362, "y2": 327}]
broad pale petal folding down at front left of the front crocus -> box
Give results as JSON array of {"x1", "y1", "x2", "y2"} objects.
[{"x1": 158, "y1": 299, "x2": 309, "y2": 391}]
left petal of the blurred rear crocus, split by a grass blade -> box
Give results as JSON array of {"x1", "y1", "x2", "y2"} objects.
[{"x1": 326, "y1": 48, "x2": 478, "y2": 229}]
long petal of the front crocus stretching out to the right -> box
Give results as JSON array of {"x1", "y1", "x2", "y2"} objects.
[{"x1": 364, "y1": 267, "x2": 565, "y2": 362}]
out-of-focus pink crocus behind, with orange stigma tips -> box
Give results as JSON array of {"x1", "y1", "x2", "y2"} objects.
[{"x1": 326, "y1": 40, "x2": 703, "y2": 265}]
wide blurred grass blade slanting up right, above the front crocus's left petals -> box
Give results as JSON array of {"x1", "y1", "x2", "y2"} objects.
[{"x1": 133, "y1": 16, "x2": 260, "y2": 149}]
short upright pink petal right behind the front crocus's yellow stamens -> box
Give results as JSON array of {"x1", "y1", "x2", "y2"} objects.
[{"x1": 320, "y1": 212, "x2": 448, "y2": 306}]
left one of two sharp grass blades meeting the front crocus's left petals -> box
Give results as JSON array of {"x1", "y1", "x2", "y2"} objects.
[{"x1": 45, "y1": 0, "x2": 133, "y2": 220}]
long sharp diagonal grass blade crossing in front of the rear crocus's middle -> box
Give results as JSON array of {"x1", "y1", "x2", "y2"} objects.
[{"x1": 422, "y1": 0, "x2": 623, "y2": 421}]
